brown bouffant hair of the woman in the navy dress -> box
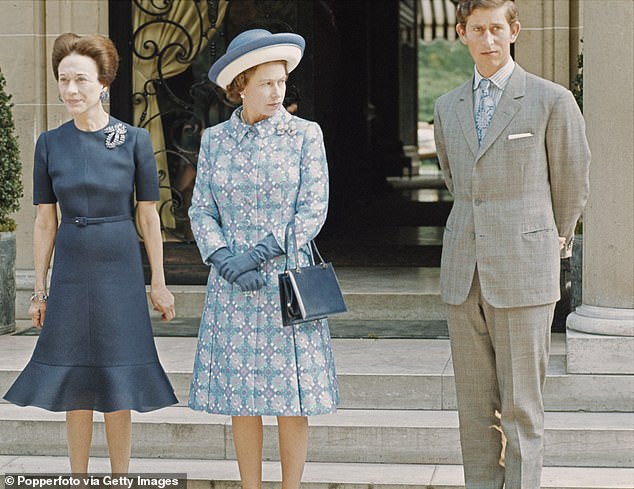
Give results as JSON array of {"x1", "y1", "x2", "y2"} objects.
[{"x1": 52, "y1": 32, "x2": 119, "y2": 87}]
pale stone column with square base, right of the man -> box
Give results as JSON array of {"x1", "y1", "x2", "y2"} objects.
[{"x1": 566, "y1": 0, "x2": 634, "y2": 374}]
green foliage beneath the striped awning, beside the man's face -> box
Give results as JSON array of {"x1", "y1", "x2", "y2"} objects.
[{"x1": 418, "y1": 40, "x2": 473, "y2": 122}]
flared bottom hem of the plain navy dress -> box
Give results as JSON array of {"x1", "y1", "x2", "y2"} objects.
[{"x1": 4, "y1": 361, "x2": 178, "y2": 413}]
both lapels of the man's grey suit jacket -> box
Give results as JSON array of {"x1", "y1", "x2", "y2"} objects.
[{"x1": 456, "y1": 63, "x2": 526, "y2": 160}]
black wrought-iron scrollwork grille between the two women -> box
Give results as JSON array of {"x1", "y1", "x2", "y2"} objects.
[{"x1": 129, "y1": 0, "x2": 300, "y2": 242}]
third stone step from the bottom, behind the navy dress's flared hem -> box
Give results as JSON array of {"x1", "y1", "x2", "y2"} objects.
[{"x1": 0, "y1": 336, "x2": 634, "y2": 412}]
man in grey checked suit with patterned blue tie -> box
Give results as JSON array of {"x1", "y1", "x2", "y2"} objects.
[{"x1": 434, "y1": 0, "x2": 590, "y2": 489}]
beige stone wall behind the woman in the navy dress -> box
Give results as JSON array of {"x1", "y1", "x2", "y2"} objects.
[{"x1": 0, "y1": 0, "x2": 108, "y2": 268}]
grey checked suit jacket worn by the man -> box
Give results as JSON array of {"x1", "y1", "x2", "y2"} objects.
[{"x1": 434, "y1": 65, "x2": 590, "y2": 307}]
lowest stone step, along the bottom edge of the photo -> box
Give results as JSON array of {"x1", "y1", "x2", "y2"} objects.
[{"x1": 0, "y1": 456, "x2": 634, "y2": 489}]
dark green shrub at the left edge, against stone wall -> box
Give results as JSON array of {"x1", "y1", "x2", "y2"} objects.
[{"x1": 0, "y1": 67, "x2": 23, "y2": 231}]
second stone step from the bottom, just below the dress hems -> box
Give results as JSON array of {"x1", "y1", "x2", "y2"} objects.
[{"x1": 0, "y1": 404, "x2": 634, "y2": 467}]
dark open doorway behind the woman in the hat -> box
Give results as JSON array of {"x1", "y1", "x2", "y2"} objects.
[{"x1": 110, "y1": 0, "x2": 451, "y2": 284}]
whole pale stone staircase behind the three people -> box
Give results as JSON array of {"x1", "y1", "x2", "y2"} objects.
[{"x1": 0, "y1": 268, "x2": 634, "y2": 489}]
